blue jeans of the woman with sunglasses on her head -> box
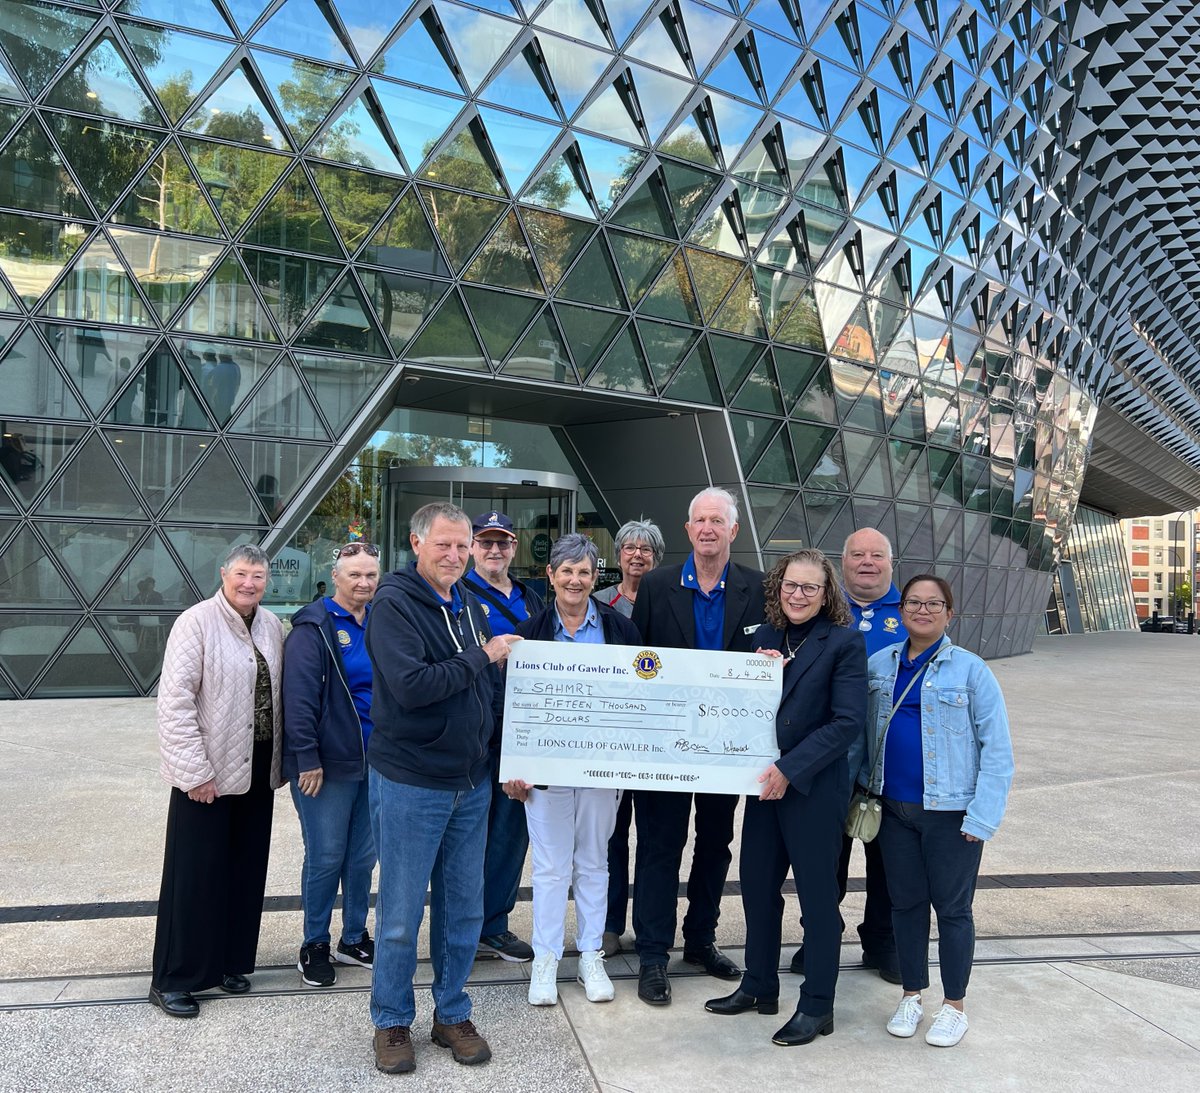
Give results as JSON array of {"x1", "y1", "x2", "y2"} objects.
[{"x1": 292, "y1": 779, "x2": 376, "y2": 945}]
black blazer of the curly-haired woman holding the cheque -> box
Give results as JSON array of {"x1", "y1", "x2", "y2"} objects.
[{"x1": 753, "y1": 614, "x2": 866, "y2": 794}]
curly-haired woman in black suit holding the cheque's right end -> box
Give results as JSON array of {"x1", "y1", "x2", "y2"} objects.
[{"x1": 704, "y1": 549, "x2": 866, "y2": 1047}]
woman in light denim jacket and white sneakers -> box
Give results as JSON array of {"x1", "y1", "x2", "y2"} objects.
[{"x1": 850, "y1": 573, "x2": 1013, "y2": 1047}]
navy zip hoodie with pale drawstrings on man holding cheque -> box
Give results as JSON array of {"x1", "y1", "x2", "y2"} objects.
[{"x1": 367, "y1": 561, "x2": 504, "y2": 791}]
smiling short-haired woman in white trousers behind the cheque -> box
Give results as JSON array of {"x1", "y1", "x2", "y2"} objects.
[{"x1": 503, "y1": 534, "x2": 641, "y2": 1005}]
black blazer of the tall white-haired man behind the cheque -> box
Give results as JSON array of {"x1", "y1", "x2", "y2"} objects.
[{"x1": 634, "y1": 561, "x2": 763, "y2": 652}]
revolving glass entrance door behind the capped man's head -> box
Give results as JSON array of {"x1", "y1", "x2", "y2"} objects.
[{"x1": 380, "y1": 467, "x2": 580, "y2": 594}]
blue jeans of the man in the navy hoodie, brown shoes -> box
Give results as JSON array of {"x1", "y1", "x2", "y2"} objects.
[{"x1": 371, "y1": 767, "x2": 492, "y2": 1028}]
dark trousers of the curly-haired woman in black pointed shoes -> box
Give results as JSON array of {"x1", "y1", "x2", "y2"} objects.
[{"x1": 740, "y1": 758, "x2": 850, "y2": 1017}]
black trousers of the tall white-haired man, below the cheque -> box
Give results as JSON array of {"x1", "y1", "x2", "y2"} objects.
[{"x1": 634, "y1": 792, "x2": 738, "y2": 965}]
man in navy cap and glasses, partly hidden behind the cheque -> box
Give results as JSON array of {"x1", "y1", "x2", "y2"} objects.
[{"x1": 463, "y1": 511, "x2": 542, "y2": 963}]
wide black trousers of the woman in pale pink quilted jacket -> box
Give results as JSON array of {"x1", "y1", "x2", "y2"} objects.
[{"x1": 151, "y1": 740, "x2": 275, "y2": 991}]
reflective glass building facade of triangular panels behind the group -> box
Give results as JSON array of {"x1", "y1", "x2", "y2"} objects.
[{"x1": 0, "y1": 0, "x2": 1200, "y2": 697}]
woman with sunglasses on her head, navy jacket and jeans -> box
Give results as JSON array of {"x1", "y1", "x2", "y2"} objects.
[{"x1": 283, "y1": 542, "x2": 379, "y2": 986}]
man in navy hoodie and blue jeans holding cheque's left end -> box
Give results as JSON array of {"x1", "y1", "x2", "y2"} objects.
[{"x1": 367, "y1": 504, "x2": 520, "y2": 1074}]
